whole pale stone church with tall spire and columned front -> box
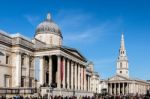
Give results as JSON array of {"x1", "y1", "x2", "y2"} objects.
[{"x1": 107, "y1": 34, "x2": 150, "y2": 95}]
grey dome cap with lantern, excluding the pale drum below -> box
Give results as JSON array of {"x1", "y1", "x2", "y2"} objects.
[{"x1": 36, "y1": 13, "x2": 62, "y2": 37}]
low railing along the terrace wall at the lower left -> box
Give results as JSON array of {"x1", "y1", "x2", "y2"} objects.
[{"x1": 0, "y1": 88, "x2": 37, "y2": 94}]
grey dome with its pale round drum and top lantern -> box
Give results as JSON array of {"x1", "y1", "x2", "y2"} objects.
[{"x1": 35, "y1": 13, "x2": 63, "y2": 46}]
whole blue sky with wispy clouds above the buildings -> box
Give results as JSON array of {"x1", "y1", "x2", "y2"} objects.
[{"x1": 0, "y1": 0, "x2": 150, "y2": 80}]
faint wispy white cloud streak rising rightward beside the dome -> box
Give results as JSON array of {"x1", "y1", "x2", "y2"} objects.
[{"x1": 64, "y1": 22, "x2": 113, "y2": 43}]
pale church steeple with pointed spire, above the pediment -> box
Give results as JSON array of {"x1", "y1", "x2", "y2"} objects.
[{"x1": 116, "y1": 34, "x2": 129, "y2": 77}]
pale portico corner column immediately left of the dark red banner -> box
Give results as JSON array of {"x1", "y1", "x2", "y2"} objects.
[{"x1": 57, "y1": 55, "x2": 61, "y2": 89}]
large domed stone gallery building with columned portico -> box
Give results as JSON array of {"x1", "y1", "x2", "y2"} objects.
[{"x1": 0, "y1": 14, "x2": 99, "y2": 97}]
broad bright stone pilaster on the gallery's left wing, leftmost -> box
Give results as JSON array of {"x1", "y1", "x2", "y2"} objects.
[{"x1": 15, "y1": 52, "x2": 21, "y2": 87}]
